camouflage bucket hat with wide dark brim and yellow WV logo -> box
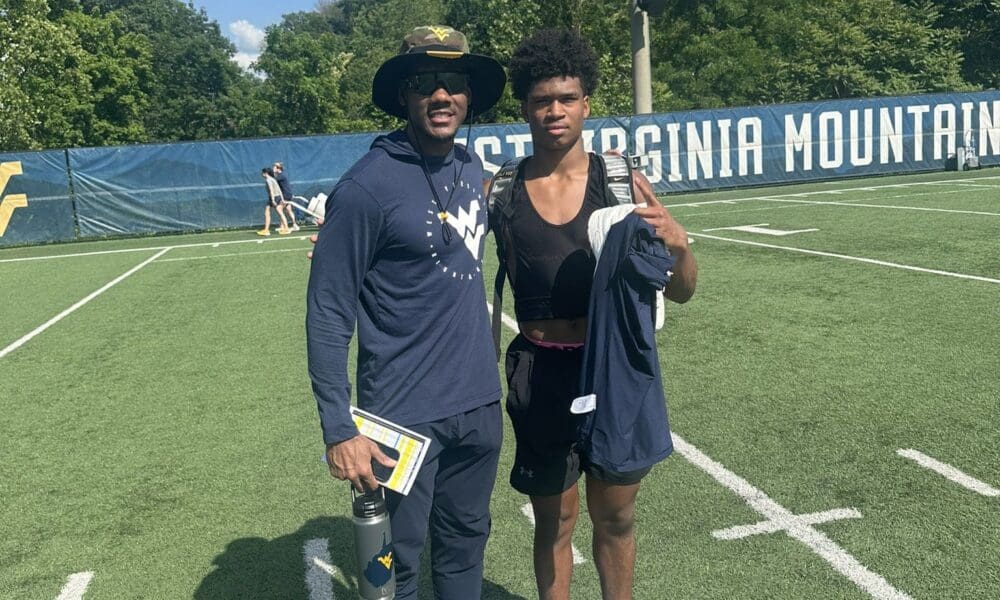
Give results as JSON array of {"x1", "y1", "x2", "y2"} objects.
[{"x1": 372, "y1": 25, "x2": 507, "y2": 120}]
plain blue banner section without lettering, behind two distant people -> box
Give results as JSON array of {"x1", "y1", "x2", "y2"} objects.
[{"x1": 69, "y1": 134, "x2": 375, "y2": 238}]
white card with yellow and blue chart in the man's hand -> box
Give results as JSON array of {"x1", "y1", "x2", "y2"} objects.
[{"x1": 351, "y1": 406, "x2": 430, "y2": 496}]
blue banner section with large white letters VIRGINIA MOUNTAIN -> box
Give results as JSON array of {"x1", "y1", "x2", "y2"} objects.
[{"x1": 471, "y1": 91, "x2": 1000, "y2": 193}]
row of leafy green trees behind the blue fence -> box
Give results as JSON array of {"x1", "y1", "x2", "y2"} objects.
[{"x1": 0, "y1": 0, "x2": 1000, "y2": 151}]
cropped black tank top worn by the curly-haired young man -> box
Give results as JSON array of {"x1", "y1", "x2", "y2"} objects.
[{"x1": 507, "y1": 154, "x2": 609, "y2": 321}]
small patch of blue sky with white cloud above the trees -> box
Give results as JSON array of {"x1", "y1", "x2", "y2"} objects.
[{"x1": 193, "y1": 0, "x2": 316, "y2": 69}]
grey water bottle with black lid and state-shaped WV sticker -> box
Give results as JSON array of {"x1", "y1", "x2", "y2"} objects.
[{"x1": 351, "y1": 486, "x2": 396, "y2": 600}]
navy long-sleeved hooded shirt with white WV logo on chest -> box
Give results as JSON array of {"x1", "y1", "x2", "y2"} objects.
[{"x1": 306, "y1": 131, "x2": 501, "y2": 444}]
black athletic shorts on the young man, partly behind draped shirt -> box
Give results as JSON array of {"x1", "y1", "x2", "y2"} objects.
[{"x1": 504, "y1": 335, "x2": 651, "y2": 496}]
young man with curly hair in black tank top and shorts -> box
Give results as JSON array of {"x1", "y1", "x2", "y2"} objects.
[{"x1": 491, "y1": 30, "x2": 697, "y2": 600}]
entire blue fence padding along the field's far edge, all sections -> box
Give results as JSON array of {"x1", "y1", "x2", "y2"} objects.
[{"x1": 0, "y1": 90, "x2": 1000, "y2": 247}]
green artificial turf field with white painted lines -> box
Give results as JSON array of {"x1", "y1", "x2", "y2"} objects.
[{"x1": 0, "y1": 170, "x2": 1000, "y2": 600}]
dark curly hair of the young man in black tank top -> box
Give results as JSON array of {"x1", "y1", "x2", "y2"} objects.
[{"x1": 508, "y1": 29, "x2": 599, "y2": 101}]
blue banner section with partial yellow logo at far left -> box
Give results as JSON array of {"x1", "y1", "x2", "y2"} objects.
[{"x1": 0, "y1": 150, "x2": 76, "y2": 247}]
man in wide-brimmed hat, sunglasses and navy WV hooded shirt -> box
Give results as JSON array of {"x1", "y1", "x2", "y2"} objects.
[{"x1": 306, "y1": 27, "x2": 506, "y2": 600}]
